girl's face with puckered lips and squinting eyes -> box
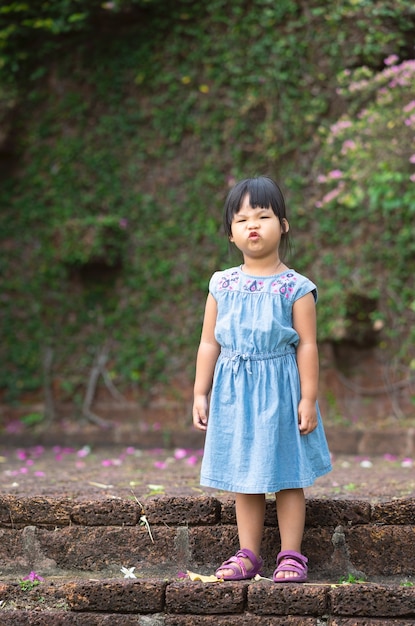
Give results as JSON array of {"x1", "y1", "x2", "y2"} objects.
[{"x1": 229, "y1": 195, "x2": 289, "y2": 258}]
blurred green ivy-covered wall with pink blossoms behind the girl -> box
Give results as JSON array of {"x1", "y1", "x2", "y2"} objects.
[{"x1": 0, "y1": 0, "x2": 415, "y2": 410}]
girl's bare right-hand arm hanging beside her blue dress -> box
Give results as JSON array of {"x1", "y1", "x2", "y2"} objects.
[{"x1": 293, "y1": 293, "x2": 319, "y2": 435}]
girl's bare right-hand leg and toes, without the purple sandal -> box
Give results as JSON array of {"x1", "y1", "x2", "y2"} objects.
[{"x1": 275, "y1": 489, "x2": 305, "y2": 578}]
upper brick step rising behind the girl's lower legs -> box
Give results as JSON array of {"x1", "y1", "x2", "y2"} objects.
[{"x1": 0, "y1": 495, "x2": 415, "y2": 581}]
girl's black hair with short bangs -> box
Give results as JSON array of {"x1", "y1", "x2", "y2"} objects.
[{"x1": 223, "y1": 176, "x2": 290, "y2": 258}]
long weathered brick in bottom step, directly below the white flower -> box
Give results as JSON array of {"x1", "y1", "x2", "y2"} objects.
[{"x1": 64, "y1": 580, "x2": 167, "y2": 613}]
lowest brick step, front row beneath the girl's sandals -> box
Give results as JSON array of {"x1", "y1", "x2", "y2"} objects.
[{"x1": 0, "y1": 579, "x2": 415, "y2": 626}]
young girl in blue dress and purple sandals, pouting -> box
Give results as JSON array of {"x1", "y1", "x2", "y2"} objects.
[{"x1": 193, "y1": 176, "x2": 331, "y2": 583}]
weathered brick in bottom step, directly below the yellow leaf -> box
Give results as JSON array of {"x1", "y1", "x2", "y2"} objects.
[{"x1": 166, "y1": 581, "x2": 247, "y2": 615}]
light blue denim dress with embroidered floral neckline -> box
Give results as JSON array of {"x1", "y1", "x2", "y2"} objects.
[{"x1": 200, "y1": 267, "x2": 331, "y2": 493}]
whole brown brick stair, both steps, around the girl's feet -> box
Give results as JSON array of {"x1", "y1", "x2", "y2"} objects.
[{"x1": 0, "y1": 495, "x2": 415, "y2": 626}]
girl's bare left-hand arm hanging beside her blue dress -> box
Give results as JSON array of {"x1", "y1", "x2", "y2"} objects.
[{"x1": 193, "y1": 294, "x2": 220, "y2": 430}]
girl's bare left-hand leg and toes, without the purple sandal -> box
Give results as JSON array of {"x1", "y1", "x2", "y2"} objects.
[{"x1": 217, "y1": 493, "x2": 265, "y2": 576}]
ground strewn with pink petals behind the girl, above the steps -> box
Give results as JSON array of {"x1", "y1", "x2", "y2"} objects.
[{"x1": 0, "y1": 446, "x2": 415, "y2": 502}]
